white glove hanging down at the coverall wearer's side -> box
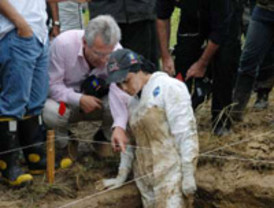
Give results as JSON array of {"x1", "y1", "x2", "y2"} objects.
[{"x1": 182, "y1": 163, "x2": 197, "y2": 197}]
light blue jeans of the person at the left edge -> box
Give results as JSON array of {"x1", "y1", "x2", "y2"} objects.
[{"x1": 0, "y1": 30, "x2": 49, "y2": 119}]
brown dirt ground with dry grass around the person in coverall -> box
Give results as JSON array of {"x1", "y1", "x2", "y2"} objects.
[{"x1": 0, "y1": 91, "x2": 274, "y2": 208}]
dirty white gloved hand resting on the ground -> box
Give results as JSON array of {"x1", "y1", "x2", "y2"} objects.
[{"x1": 95, "y1": 170, "x2": 128, "y2": 191}]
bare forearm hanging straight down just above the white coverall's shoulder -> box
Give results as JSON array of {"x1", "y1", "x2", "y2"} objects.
[{"x1": 157, "y1": 19, "x2": 175, "y2": 76}]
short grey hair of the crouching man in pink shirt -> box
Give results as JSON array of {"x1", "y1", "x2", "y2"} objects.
[{"x1": 85, "y1": 15, "x2": 121, "y2": 47}]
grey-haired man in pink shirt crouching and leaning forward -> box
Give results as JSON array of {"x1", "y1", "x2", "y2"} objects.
[{"x1": 43, "y1": 15, "x2": 130, "y2": 155}]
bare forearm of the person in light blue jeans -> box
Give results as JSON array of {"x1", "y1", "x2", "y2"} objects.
[{"x1": 0, "y1": 0, "x2": 33, "y2": 37}]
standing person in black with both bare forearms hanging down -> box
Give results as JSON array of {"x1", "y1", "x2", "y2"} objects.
[{"x1": 156, "y1": 0, "x2": 241, "y2": 136}]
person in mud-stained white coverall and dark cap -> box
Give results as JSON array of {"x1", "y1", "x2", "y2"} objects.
[{"x1": 97, "y1": 49, "x2": 199, "y2": 208}]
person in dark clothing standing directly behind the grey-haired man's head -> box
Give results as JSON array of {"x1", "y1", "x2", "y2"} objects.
[{"x1": 89, "y1": 0, "x2": 158, "y2": 66}]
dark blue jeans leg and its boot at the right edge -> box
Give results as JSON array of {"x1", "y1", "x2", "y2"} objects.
[{"x1": 233, "y1": 20, "x2": 274, "y2": 120}]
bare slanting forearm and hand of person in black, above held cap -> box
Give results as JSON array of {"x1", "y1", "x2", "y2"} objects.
[{"x1": 186, "y1": 40, "x2": 219, "y2": 80}]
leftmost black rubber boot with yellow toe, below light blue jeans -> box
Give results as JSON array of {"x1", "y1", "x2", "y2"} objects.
[{"x1": 0, "y1": 121, "x2": 33, "y2": 187}]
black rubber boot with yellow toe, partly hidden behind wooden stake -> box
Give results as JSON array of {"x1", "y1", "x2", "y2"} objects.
[{"x1": 18, "y1": 116, "x2": 72, "y2": 175}]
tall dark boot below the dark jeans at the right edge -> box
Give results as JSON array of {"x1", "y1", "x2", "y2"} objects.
[{"x1": 231, "y1": 74, "x2": 255, "y2": 121}]
